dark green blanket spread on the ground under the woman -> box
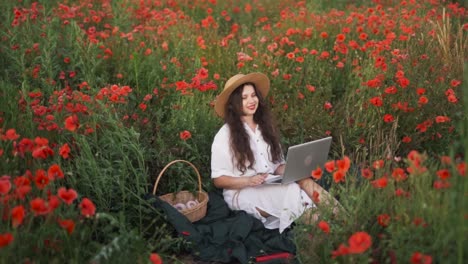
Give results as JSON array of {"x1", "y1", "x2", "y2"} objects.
[{"x1": 153, "y1": 191, "x2": 296, "y2": 264}]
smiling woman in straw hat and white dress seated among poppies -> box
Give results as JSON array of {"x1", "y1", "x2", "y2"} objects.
[{"x1": 211, "y1": 73, "x2": 338, "y2": 232}]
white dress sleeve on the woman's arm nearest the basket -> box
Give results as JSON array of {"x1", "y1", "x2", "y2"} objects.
[{"x1": 211, "y1": 128, "x2": 236, "y2": 178}]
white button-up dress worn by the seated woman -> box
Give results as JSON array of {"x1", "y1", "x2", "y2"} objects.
[{"x1": 211, "y1": 123, "x2": 315, "y2": 233}]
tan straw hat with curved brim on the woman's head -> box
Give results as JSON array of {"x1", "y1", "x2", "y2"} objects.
[{"x1": 215, "y1": 72, "x2": 270, "y2": 117}]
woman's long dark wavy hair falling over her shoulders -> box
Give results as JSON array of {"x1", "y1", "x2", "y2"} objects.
[{"x1": 224, "y1": 83, "x2": 282, "y2": 173}]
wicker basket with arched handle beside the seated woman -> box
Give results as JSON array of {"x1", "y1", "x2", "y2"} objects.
[{"x1": 153, "y1": 160, "x2": 208, "y2": 222}]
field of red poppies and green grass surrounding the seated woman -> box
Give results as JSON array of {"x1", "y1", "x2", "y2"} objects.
[{"x1": 0, "y1": 0, "x2": 468, "y2": 264}]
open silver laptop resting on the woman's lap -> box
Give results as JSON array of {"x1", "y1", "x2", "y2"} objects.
[{"x1": 263, "y1": 137, "x2": 332, "y2": 184}]
